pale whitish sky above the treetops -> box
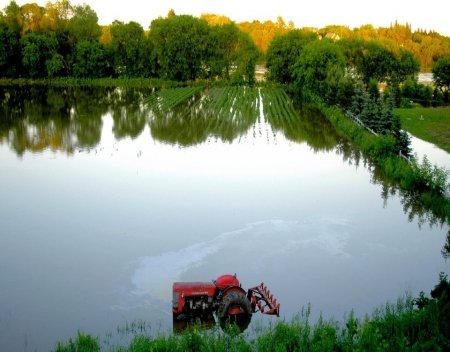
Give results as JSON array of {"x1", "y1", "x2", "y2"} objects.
[{"x1": 0, "y1": 0, "x2": 450, "y2": 36}]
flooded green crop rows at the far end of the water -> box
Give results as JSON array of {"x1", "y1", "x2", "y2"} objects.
[{"x1": 145, "y1": 86, "x2": 299, "y2": 145}]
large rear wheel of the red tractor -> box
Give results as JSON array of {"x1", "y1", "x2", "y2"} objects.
[{"x1": 217, "y1": 292, "x2": 252, "y2": 332}]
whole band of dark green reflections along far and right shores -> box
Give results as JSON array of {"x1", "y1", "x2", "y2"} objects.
[{"x1": 0, "y1": 86, "x2": 447, "y2": 232}]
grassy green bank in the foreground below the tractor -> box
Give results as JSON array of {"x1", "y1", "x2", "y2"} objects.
[{"x1": 56, "y1": 274, "x2": 450, "y2": 352}]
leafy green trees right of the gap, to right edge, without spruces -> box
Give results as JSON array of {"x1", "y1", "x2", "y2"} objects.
[{"x1": 266, "y1": 29, "x2": 450, "y2": 107}]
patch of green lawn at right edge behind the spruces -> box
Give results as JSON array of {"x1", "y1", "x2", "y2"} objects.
[{"x1": 395, "y1": 107, "x2": 450, "y2": 153}]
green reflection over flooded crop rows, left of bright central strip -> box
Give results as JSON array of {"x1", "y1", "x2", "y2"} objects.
[{"x1": 150, "y1": 87, "x2": 259, "y2": 146}]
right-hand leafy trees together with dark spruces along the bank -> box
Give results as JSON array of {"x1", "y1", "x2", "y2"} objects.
[{"x1": 266, "y1": 29, "x2": 450, "y2": 156}]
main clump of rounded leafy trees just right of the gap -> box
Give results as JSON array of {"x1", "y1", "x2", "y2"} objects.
[{"x1": 267, "y1": 30, "x2": 420, "y2": 95}]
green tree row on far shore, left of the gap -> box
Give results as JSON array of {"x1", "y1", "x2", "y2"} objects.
[{"x1": 0, "y1": 0, "x2": 258, "y2": 83}]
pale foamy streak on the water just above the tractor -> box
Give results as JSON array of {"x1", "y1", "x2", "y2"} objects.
[{"x1": 125, "y1": 218, "x2": 350, "y2": 301}]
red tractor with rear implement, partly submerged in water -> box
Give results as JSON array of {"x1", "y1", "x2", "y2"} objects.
[{"x1": 172, "y1": 275, "x2": 280, "y2": 331}]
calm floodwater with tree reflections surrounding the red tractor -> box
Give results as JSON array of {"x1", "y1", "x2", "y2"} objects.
[{"x1": 0, "y1": 87, "x2": 450, "y2": 352}]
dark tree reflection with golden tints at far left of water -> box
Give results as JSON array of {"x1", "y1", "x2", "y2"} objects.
[{"x1": 0, "y1": 86, "x2": 107, "y2": 155}]
